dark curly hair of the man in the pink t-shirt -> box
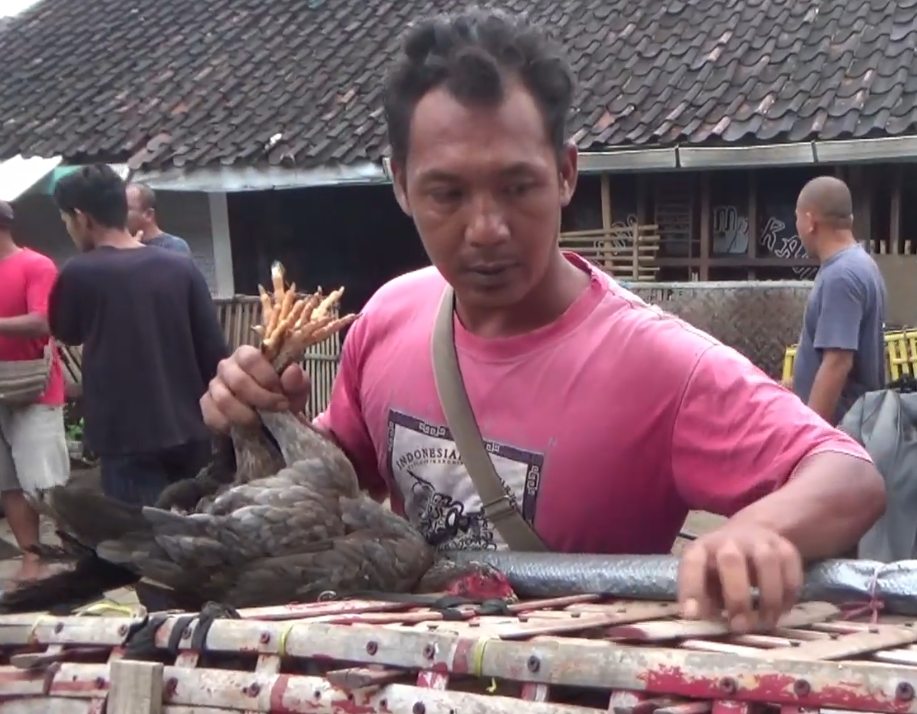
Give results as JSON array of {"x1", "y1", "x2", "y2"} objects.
[{"x1": 384, "y1": 7, "x2": 576, "y2": 164}]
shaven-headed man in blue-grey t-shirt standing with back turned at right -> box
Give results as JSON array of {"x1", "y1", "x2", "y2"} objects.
[{"x1": 792, "y1": 176, "x2": 886, "y2": 425}]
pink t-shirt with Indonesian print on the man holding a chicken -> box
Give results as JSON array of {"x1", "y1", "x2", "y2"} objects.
[{"x1": 317, "y1": 255, "x2": 869, "y2": 554}]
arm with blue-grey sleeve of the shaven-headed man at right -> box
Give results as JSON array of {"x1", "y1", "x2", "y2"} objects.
[{"x1": 809, "y1": 271, "x2": 864, "y2": 424}]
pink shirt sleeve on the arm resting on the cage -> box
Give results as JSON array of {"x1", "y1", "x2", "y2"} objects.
[{"x1": 672, "y1": 345, "x2": 871, "y2": 516}]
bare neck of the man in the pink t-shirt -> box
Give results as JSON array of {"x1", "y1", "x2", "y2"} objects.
[{"x1": 456, "y1": 250, "x2": 589, "y2": 338}]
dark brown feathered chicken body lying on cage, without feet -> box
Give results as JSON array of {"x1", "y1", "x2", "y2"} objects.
[{"x1": 35, "y1": 413, "x2": 434, "y2": 607}]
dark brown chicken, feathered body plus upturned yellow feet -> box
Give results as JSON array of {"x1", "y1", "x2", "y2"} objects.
[{"x1": 0, "y1": 264, "x2": 458, "y2": 612}]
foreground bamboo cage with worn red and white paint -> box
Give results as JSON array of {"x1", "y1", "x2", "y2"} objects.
[{"x1": 0, "y1": 595, "x2": 917, "y2": 714}]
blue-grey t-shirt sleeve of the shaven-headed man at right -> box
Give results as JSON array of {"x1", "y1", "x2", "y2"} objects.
[{"x1": 813, "y1": 270, "x2": 864, "y2": 351}]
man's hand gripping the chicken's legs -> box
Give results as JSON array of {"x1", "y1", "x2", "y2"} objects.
[{"x1": 201, "y1": 345, "x2": 312, "y2": 433}]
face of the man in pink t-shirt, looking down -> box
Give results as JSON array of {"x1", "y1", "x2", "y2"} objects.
[{"x1": 393, "y1": 84, "x2": 577, "y2": 309}]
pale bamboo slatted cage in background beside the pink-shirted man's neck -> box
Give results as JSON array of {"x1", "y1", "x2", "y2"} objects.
[{"x1": 560, "y1": 224, "x2": 660, "y2": 281}]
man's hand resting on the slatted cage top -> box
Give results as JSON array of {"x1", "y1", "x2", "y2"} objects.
[{"x1": 678, "y1": 523, "x2": 803, "y2": 632}]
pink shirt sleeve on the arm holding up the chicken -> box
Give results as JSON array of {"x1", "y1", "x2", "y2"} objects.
[{"x1": 314, "y1": 317, "x2": 388, "y2": 499}]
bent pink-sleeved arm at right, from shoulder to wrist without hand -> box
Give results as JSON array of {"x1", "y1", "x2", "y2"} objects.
[{"x1": 672, "y1": 345, "x2": 885, "y2": 560}]
